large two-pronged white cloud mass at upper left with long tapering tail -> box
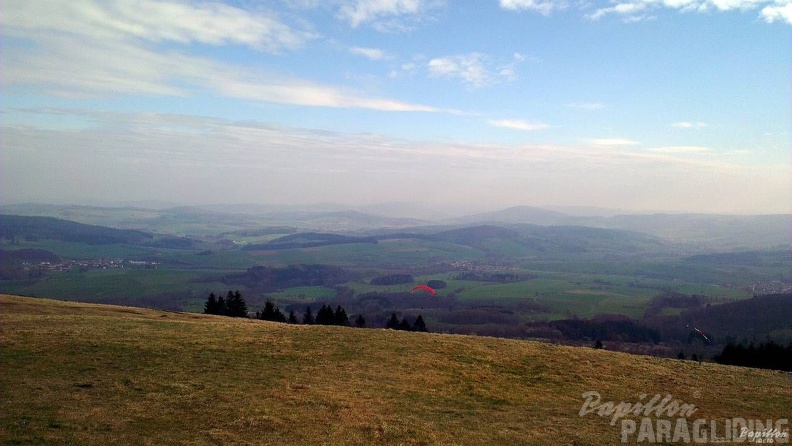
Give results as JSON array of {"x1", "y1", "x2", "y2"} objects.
[{"x1": 0, "y1": 0, "x2": 442, "y2": 112}]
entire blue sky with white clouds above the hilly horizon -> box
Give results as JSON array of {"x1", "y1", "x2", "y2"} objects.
[{"x1": 0, "y1": 0, "x2": 792, "y2": 214}]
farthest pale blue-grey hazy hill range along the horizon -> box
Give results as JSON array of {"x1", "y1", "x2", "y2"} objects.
[{"x1": 0, "y1": 203, "x2": 792, "y2": 254}]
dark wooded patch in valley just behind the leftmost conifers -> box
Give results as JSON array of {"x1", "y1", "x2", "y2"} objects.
[{"x1": 221, "y1": 265, "x2": 354, "y2": 292}]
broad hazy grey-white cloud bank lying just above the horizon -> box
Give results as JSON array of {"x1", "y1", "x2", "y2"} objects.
[{"x1": 0, "y1": 110, "x2": 792, "y2": 210}]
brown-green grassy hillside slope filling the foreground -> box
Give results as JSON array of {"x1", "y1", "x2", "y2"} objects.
[{"x1": 0, "y1": 295, "x2": 792, "y2": 445}]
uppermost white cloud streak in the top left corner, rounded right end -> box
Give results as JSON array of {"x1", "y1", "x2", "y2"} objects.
[{"x1": 0, "y1": 0, "x2": 315, "y2": 52}]
